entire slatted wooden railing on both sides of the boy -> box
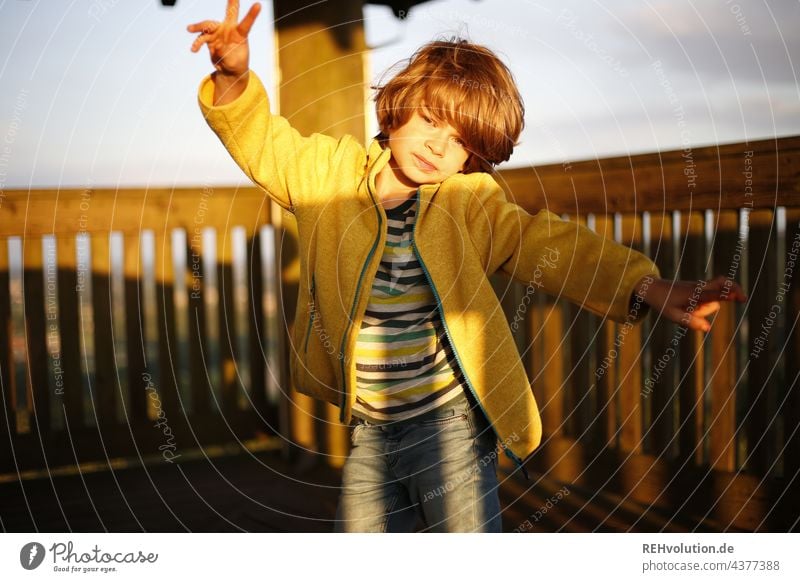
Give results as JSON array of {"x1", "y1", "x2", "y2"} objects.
[{"x1": 0, "y1": 138, "x2": 800, "y2": 531}]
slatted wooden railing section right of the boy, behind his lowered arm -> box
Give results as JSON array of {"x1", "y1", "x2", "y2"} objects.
[{"x1": 496, "y1": 138, "x2": 800, "y2": 531}]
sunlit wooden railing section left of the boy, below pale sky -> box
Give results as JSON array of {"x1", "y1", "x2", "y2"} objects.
[{"x1": 0, "y1": 187, "x2": 286, "y2": 477}]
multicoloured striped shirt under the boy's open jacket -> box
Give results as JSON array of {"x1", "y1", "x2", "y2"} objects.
[{"x1": 353, "y1": 196, "x2": 465, "y2": 423}]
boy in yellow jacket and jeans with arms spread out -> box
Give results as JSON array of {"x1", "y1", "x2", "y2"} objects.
[{"x1": 188, "y1": 0, "x2": 743, "y2": 532}]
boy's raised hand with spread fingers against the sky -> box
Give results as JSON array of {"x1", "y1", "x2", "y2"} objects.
[{"x1": 186, "y1": 0, "x2": 261, "y2": 77}]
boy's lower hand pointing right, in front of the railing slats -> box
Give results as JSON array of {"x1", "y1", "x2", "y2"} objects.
[{"x1": 634, "y1": 277, "x2": 747, "y2": 331}]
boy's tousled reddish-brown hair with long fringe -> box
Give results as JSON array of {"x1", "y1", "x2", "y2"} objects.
[{"x1": 373, "y1": 38, "x2": 525, "y2": 173}]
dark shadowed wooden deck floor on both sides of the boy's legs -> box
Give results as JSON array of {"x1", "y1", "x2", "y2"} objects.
[{"x1": 0, "y1": 451, "x2": 736, "y2": 532}]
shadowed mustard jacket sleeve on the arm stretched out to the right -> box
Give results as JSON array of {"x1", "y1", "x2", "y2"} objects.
[{"x1": 468, "y1": 175, "x2": 659, "y2": 322}]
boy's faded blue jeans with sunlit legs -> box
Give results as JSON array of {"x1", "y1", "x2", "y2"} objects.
[{"x1": 335, "y1": 402, "x2": 502, "y2": 532}]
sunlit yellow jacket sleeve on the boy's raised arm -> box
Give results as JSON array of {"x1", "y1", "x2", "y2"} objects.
[{"x1": 198, "y1": 70, "x2": 351, "y2": 212}]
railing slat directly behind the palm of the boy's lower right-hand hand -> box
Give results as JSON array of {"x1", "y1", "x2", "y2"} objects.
[{"x1": 676, "y1": 212, "x2": 706, "y2": 465}]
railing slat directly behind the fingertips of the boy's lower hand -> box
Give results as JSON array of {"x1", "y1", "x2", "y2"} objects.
[{"x1": 708, "y1": 210, "x2": 744, "y2": 471}]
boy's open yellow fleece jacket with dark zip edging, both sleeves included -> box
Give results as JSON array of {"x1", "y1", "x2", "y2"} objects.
[{"x1": 198, "y1": 71, "x2": 658, "y2": 464}]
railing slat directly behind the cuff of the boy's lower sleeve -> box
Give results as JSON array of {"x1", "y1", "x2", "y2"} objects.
[{"x1": 615, "y1": 214, "x2": 643, "y2": 453}]
